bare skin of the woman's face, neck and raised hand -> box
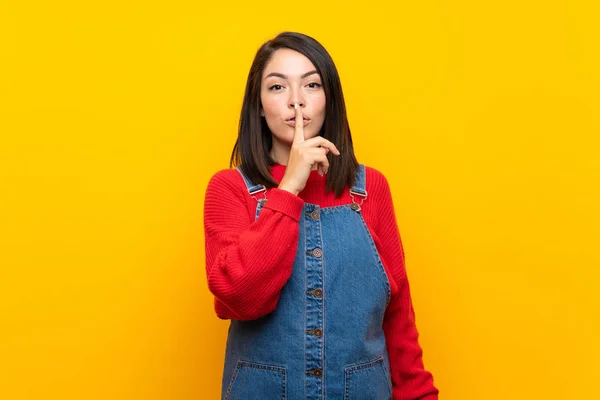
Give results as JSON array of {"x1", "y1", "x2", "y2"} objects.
[{"x1": 261, "y1": 48, "x2": 340, "y2": 195}]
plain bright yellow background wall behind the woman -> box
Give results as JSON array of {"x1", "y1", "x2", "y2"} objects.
[{"x1": 0, "y1": 0, "x2": 600, "y2": 400}]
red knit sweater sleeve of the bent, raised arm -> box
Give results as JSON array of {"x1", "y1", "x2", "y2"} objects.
[{"x1": 204, "y1": 170, "x2": 304, "y2": 320}]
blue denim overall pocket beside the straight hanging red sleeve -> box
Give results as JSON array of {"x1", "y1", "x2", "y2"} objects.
[{"x1": 344, "y1": 357, "x2": 392, "y2": 400}]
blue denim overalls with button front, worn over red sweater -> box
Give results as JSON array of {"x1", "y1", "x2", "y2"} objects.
[{"x1": 222, "y1": 164, "x2": 392, "y2": 400}]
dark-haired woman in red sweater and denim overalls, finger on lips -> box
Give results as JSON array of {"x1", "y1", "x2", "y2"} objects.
[{"x1": 204, "y1": 32, "x2": 438, "y2": 400}]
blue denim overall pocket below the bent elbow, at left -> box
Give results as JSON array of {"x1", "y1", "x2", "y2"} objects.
[{"x1": 224, "y1": 361, "x2": 286, "y2": 400}]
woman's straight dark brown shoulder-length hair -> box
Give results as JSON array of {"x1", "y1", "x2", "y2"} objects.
[{"x1": 229, "y1": 32, "x2": 358, "y2": 197}]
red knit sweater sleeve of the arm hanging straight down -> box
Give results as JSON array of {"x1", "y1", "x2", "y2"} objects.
[{"x1": 373, "y1": 173, "x2": 438, "y2": 400}]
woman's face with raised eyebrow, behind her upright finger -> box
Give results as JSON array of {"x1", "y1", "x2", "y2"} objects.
[{"x1": 260, "y1": 48, "x2": 325, "y2": 146}]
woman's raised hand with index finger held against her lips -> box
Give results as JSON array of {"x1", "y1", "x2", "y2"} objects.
[{"x1": 279, "y1": 103, "x2": 340, "y2": 195}]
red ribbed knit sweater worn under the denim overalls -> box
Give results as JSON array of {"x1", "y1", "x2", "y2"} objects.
[{"x1": 204, "y1": 164, "x2": 438, "y2": 400}]
